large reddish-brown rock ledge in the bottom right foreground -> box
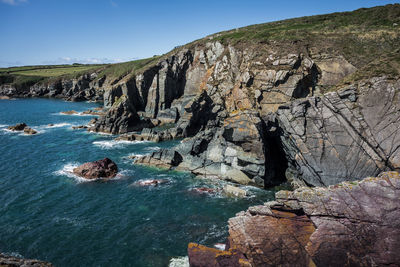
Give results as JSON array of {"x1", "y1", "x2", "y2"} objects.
[{"x1": 188, "y1": 172, "x2": 400, "y2": 266}]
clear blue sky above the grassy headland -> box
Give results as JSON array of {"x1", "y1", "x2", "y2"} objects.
[{"x1": 0, "y1": 0, "x2": 400, "y2": 67}]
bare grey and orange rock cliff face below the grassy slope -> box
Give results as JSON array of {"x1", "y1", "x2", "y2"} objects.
[{"x1": 122, "y1": 39, "x2": 400, "y2": 186}]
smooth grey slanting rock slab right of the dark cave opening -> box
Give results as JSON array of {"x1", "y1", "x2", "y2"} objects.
[{"x1": 277, "y1": 78, "x2": 400, "y2": 186}]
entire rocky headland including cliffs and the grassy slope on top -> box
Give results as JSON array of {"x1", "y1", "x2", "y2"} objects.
[{"x1": 0, "y1": 5, "x2": 400, "y2": 187}]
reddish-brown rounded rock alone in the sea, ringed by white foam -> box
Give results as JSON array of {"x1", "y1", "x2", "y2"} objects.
[{"x1": 73, "y1": 158, "x2": 118, "y2": 179}]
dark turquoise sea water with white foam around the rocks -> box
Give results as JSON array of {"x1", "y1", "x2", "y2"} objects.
[{"x1": 0, "y1": 99, "x2": 273, "y2": 266}]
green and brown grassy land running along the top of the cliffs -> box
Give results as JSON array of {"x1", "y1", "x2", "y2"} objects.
[{"x1": 0, "y1": 4, "x2": 400, "y2": 86}]
